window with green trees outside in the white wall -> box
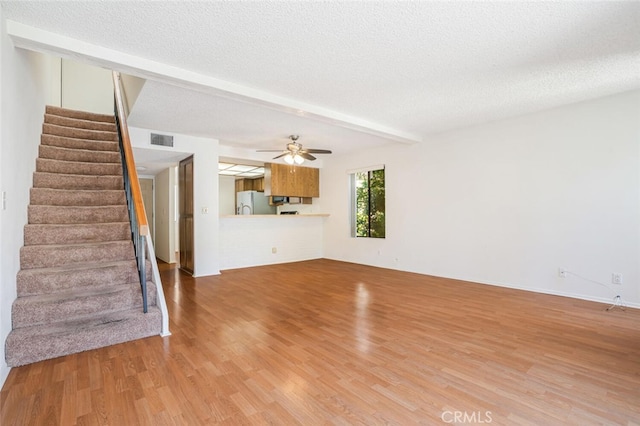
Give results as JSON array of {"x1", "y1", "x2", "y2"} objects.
[{"x1": 350, "y1": 166, "x2": 385, "y2": 238}]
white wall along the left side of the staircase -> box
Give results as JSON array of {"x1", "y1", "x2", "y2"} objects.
[{"x1": 0, "y1": 13, "x2": 55, "y2": 386}]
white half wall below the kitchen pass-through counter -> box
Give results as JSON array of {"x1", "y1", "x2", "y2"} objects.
[{"x1": 220, "y1": 215, "x2": 327, "y2": 269}]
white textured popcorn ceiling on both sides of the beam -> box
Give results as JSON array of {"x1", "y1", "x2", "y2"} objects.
[{"x1": 2, "y1": 1, "x2": 640, "y2": 160}]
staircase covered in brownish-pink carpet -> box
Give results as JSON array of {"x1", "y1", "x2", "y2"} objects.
[{"x1": 5, "y1": 107, "x2": 162, "y2": 367}]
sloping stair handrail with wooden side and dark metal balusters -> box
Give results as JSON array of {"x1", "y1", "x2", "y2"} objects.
[{"x1": 112, "y1": 71, "x2": 149, "y2": 314}]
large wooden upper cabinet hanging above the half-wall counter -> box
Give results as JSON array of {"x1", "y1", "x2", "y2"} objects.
[{"x1": 264, "y1": 163, "x2": 320, "y2": 198}]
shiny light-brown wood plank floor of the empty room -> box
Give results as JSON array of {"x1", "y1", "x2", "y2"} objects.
[{"x1": 0, "y1": 260, "x2": 640, "y2": 426}]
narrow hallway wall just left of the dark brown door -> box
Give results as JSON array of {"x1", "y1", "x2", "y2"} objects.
[{"x1": 154, "y1": 168, "x2": 176, "y2": 263}]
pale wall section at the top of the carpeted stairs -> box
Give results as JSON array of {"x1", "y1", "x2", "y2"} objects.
[{"x1": 62, "y1": 59, "x2": 113, "y2": 115}]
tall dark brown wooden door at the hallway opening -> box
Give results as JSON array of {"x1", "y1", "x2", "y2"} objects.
[{"x1": 178, "y1": 156, "x2": 195, "y2": 274}]
